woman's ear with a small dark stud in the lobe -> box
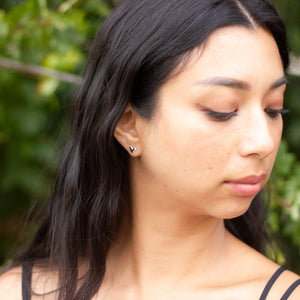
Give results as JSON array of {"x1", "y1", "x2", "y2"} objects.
[{"x1": 114, "y1": 104, "x2": 141, "y2": 157}]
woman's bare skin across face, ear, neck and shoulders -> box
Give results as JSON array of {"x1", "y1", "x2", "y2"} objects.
[{"x1": 0, "y1": 26, "x2": 300, "y2": 300}]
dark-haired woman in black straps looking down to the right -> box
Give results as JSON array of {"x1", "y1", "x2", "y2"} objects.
[{"x1": 0, "y1": 0, "x2": 300, "y2": 300}]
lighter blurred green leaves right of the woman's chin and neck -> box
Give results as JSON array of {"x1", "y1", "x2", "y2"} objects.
[{"x1": 268, "y1": 141, "x2": 300, "y2": 273}]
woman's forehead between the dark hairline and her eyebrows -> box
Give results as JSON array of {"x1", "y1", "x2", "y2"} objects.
[{"x1": 175, "y1": 26, "x2": 284, "y2": 83}]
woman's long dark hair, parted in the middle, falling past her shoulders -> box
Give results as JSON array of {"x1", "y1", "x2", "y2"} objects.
[{"x1": 11, "y1": 0, "x2": 289, "y2": 300}]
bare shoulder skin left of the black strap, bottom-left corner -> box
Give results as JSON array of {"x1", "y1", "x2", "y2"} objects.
[{"x1": 0, "y1": 267, "x2": 22, "y2": 300}]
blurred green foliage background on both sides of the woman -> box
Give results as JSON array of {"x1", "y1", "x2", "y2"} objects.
[{"x1": 0, "y1": 0, "x2": 300, "y2": 273}]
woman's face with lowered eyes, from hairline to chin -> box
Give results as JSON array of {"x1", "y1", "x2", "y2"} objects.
[{"x1": 134, "y1": 26, "x2": 286, "y2": 218}]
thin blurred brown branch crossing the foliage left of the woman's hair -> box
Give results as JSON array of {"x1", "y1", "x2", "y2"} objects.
[{"x1": 0, "y1": 56, "x2": 82, "y2": 84}]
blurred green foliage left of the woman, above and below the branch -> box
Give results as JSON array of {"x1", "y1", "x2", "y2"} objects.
[{"x1": 0, "y1": 0, "x2": 110, "y2": 264}]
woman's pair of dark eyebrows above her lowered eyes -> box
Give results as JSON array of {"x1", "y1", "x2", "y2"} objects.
[{"x1": 195, "y1": 76, "x2": 288, "y2": 91}]
